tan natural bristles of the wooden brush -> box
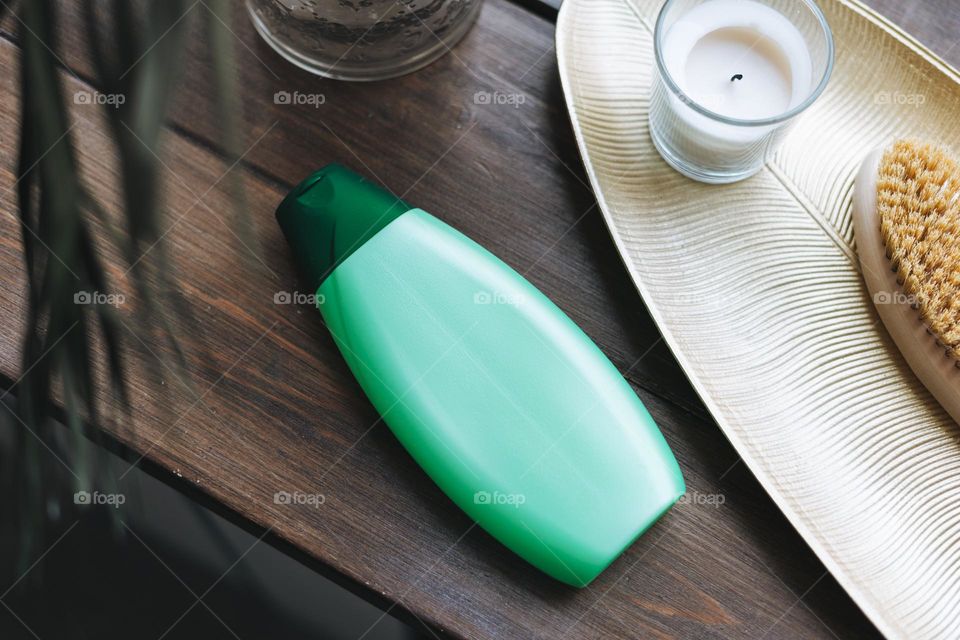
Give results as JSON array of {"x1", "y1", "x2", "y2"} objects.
[{"x1": 877, "y1": 140, "x2": 960, "y2": 361}]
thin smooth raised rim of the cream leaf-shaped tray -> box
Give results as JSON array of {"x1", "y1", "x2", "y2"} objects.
[{"x1": 554, "y1": 0, "x2": 960, "y2": 638}]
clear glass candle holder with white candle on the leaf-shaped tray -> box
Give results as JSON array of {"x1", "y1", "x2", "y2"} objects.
[{"x1": 649, "y1": 0, "x2": 833, "y2": 184}]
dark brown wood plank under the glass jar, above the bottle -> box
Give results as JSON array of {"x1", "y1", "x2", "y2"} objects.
[{"x1": 13, "y1": 0, "x2": 707, "y2": 417}]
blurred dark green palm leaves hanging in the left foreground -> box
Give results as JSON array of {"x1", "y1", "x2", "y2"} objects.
[{"x1": 0, "y1": 0, "x2": 248, "y2": 563}]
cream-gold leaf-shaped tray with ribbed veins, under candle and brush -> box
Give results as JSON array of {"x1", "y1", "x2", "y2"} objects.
[{"x1": 557, "y1": 0, "x2": 960, "y2": 640}]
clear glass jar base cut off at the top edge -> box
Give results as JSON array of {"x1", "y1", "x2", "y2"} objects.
[{"x1": 247, "y1": 0, "x2": 481, "y2": 80}]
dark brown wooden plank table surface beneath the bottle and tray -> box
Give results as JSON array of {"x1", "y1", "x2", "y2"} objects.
[{"x1": 0, "y1": 0, "x2": 960, "y2": 638}]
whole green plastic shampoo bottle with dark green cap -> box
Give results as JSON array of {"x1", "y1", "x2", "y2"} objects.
[{"x1": 277, "y1": 165, "x2": 684, "y2": 587}]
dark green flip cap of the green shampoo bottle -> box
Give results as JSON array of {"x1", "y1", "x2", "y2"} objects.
[{"x1": 277, "y1": 164, "x2": 412, "y2": 287}]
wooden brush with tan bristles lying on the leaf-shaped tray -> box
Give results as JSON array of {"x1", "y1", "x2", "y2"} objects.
[{"x1": 853, "y1": 140, "x2": 960, "y2": 423}]
